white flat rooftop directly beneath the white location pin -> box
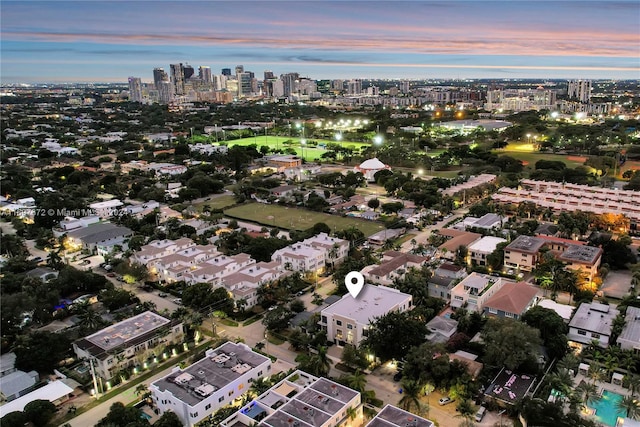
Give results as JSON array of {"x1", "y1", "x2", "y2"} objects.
[{"x1": 322, "y1": 284, "x2": 411, "y2": 324}]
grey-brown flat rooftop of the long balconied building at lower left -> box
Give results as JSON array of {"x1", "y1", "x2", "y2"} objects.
[{"x1": 85, "y1": 311, "x2": 171, "y2": 351}]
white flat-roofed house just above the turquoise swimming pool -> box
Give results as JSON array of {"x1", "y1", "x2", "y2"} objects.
[{"x1": 567, "y1": 302, "x2": 619, "y2": 347}]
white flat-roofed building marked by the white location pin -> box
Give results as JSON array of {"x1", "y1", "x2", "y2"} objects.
[{"x1": 319, "y1": 285, "x2": 413, "y2": 346}]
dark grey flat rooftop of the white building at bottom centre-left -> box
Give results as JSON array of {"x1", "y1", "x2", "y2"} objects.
[{"x1": 152, "y1": 342, "x2": 269, "y2": 406}]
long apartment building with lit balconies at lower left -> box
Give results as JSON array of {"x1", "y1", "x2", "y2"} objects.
[{"x1": 73, "y1": 311, "x2": 184, "y2": 380}]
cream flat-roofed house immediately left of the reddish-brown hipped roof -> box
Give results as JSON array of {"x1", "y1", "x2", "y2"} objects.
[{"x1": 451, "y1": 272, "x2": 505, "y2": 313}]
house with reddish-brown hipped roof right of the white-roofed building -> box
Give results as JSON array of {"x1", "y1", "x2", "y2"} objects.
[{"x1": 483, "y1": 282, "x2": 539, "y2": 319}]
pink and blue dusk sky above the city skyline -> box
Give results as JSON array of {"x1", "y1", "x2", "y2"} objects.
[{"x1": 0, "y1": 0, "x2": 640, "y2": 83}]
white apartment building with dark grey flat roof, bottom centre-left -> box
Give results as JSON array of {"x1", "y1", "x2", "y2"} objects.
[{"x1": 149, "y1": 342, "x2": 271, "y2": 427}]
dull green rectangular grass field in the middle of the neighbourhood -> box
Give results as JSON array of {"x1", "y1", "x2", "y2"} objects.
[{"x1": 224, "y1": 203, "x2": 382, "y2": 236}]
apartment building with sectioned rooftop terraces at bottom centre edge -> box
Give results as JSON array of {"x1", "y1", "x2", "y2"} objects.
[{"x1": 220, "y1": 370, "x2": 360, "y2": 427}]
